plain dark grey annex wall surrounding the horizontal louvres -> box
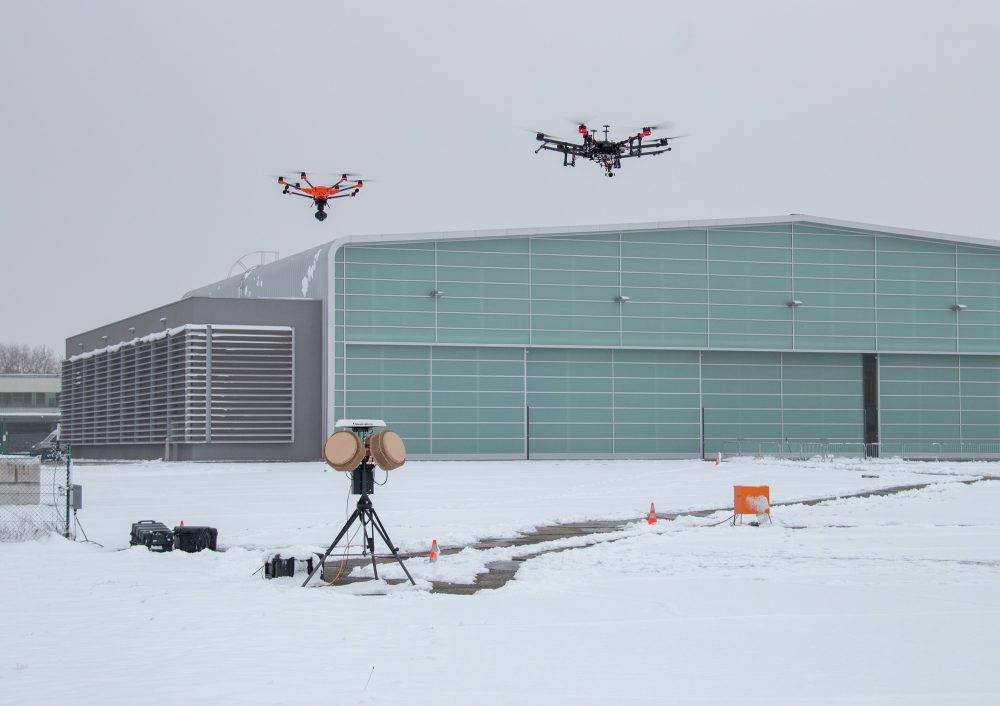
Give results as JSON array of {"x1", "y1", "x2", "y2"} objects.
[{"x1": 66, "y1": 297, "x2": 325, "y2": 461}]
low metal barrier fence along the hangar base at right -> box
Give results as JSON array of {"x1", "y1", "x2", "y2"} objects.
[{"x1": 720, "y1": 439, "x2": 1000, "y2": 461}]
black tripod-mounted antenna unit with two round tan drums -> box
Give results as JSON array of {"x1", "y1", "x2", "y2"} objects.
[{"x1": 302, "y1": 419, "x2": 417, "y2": 586}]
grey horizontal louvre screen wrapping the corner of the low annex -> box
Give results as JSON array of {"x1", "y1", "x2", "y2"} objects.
[{"x1": 62, "y1": 324, "x2": 294, "y2": 445}]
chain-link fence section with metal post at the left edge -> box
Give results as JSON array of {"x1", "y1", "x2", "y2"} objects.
[{"x1": 0, "y1": 454, "x2": 73, "y2": 542}]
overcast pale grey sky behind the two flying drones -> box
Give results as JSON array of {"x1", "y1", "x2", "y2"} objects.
[{"x1": 0, "y1": 0, "x2": 1000, "y2": 352}]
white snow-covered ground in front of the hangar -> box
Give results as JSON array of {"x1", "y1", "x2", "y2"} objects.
[{"x1": 0, "y1": 460, "x2": 1000, "y2": 705}]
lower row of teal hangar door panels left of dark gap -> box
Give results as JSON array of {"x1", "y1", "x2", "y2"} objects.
[{"x1": 336, "y1": 344, "x2": 864, "y2": 458}]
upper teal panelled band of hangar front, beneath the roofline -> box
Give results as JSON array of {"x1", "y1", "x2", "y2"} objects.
[{"x1": 335, "y1": 223, "x2": 1000, "y2": 353}]
